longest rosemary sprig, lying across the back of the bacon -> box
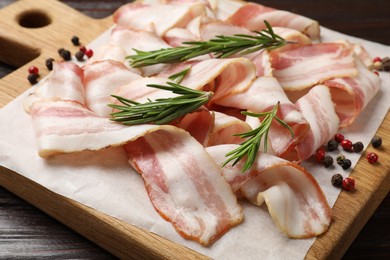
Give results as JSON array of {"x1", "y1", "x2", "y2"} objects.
[{"x1": 126, "y1": 21, "x2": 290, "y2": 68}]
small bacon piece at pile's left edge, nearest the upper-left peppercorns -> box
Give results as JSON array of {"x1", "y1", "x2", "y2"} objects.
[{"x1": 24, "y1": 62, "x2": 85, "y2": 112}]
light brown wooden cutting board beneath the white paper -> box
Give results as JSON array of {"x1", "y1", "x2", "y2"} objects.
[{"x1": 0, "y1": 0, "x2": 390, "y2": 259}]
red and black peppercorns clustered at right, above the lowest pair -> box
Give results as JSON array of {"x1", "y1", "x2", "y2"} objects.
[{"x1": 315, "y1": 134, "x2": 364, "y2": 170}]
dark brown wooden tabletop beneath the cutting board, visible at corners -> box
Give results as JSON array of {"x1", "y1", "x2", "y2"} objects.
[{"x1": 0, "y1": 0, "x2": 390, "y2": 259}]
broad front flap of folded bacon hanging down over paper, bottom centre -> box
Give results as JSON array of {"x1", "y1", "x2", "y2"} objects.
[{"x1": 125, "y1": 131, "x2": 243, "y2": 245}]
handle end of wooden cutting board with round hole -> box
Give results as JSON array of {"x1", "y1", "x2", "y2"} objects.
[{"x1": 0, "y1": 0, "x2": 113, "y2": 108}]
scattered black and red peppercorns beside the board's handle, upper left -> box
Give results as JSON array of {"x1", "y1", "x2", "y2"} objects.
[{"x1": 27, "y1": 36, "x2": 93, "y2": 85}]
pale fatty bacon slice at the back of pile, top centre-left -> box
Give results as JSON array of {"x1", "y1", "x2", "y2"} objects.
[{"x1": 114, "y1": 2, "x2": 206, "y2": 36}]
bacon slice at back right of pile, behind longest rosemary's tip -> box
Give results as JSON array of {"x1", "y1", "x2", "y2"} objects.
[{"x1": 226, "y1": 3, "x2": 320, "y2": 40}]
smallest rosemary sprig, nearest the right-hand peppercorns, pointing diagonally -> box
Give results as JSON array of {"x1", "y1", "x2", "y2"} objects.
[{"x1": 222, "y1": 102, "x2": 294, "y2": 172}]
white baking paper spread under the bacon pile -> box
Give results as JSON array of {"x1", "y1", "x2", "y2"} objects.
[{"x1": 0, "y1": 28, "x2": 390, "y2": 260}]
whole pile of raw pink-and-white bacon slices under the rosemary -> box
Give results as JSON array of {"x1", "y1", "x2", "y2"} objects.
[{"x1": 25, "y1": 0, "x2": 380, "y2": 246}]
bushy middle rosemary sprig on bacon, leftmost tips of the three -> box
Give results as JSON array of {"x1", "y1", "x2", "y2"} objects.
[{"x1": 108, "y1": 82, "x2": 213, "y2": 125}]
